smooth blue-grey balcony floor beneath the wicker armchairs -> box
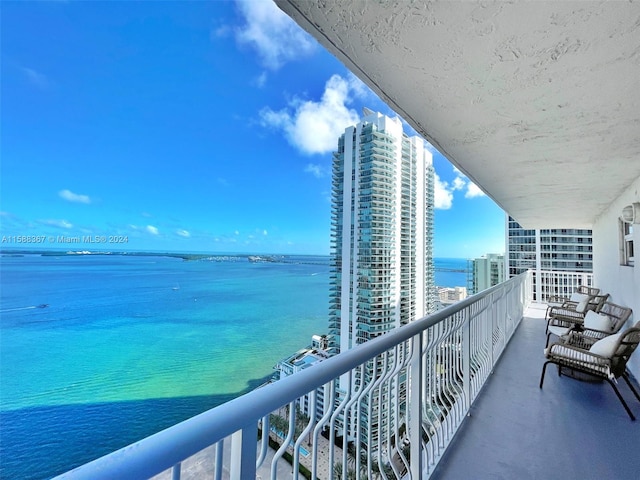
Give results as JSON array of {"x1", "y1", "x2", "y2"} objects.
[{"x1": 431, "y1": 304, "x2": 640, "y2": 480}]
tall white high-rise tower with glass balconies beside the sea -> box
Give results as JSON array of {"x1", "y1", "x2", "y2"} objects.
[{"x1": 329, "y1": 110, "x2": 435, "y2": 452}]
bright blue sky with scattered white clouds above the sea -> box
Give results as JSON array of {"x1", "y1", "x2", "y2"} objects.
[{"x1": 0, "y1": 0, "x2": 504, "y2": 258}]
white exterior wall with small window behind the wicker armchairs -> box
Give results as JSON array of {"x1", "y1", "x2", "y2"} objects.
[{"x1": 593, "y1": 174, "x2": 640, "y2": 380}]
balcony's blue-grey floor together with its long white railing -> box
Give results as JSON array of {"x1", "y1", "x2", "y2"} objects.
[{"x1": 52, "y1": 273, "x2": 640, "y2": 480}]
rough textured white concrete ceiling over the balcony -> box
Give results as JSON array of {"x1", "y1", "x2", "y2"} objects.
[{"x1": 276, "y1": 0, "x2": 640, "y2": 228}]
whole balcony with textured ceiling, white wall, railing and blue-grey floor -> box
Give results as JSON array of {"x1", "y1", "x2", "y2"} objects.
[{"x1": 51, "y1": 0, "x2": 640, "y2": 479}]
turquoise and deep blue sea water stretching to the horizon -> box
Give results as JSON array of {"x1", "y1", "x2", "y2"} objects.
[{"x1": 0, "y1": 255, "x2": 466, "y2": 479}]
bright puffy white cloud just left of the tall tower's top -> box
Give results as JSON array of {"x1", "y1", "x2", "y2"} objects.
[{"x1": 260, "y1": 75, "x2": 359, "y2": 154}]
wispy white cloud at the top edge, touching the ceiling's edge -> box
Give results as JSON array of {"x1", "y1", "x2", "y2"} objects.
[{"x1": 234, "y1": 0, "x2": 317, "y2": 70}]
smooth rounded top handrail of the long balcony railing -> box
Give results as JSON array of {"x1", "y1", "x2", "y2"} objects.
[{"x1": 56, "y1": 272, "x2": 528, "y2": 480}]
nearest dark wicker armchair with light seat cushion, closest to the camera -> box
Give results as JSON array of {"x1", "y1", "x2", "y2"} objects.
[{"x1": 540, "y1": 322, "x2": 640, "y2": 420}]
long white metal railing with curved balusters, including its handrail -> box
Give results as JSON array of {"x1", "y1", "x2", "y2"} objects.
[{"x1": 59, "y1": 272, "x2": 532, "y2": 480}]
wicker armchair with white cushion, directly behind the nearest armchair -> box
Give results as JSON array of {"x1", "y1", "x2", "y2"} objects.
[{"x1": 545, "y1": 293, "x2": 612, "y2": 347}]
